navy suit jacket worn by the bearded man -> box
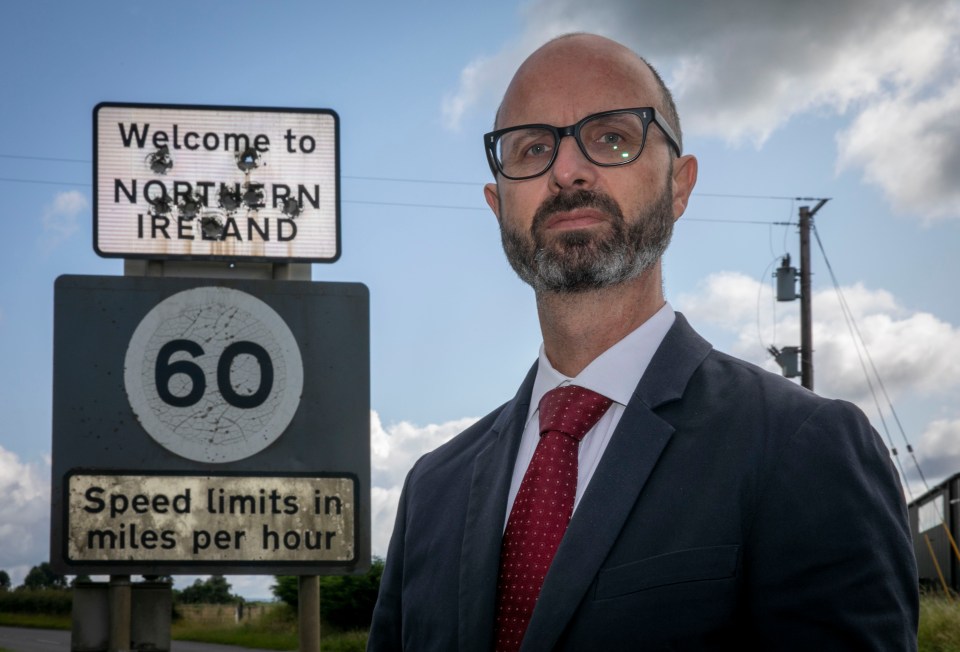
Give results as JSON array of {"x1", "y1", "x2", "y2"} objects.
[{"x1": 368, "y1": 314, "x2": 918, "y2": 652}]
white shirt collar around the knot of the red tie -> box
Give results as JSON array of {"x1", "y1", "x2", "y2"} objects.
[{"x1": 527, "y1": 303, "x2": 676, "y2": 422}]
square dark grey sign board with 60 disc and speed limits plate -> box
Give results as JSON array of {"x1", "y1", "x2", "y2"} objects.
[{"x1": 50, "y1": 275, "x2": 370, "y2": 575}]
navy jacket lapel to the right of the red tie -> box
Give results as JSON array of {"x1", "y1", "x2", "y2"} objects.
[{"x1": 516, "y1": 313, "x2": 711, "y2": 652}]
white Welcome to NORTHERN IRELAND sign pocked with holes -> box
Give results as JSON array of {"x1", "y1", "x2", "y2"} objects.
[{"x1": 93, "y1": 103, "x2": 340, "y2": 262}]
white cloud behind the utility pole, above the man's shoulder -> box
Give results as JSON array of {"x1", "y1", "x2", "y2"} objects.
[{"x1": 676, "y1": 272, "x2": 960, "y2": 402}]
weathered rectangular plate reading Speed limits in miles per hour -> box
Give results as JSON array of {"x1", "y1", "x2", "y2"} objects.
[{"x1": 66, "y1": 473, "x2": 358, "y2": 563}]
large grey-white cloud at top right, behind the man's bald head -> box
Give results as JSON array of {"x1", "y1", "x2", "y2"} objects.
[{"x1": 444, "y1": 0, "x2": 960, "y2": 218}]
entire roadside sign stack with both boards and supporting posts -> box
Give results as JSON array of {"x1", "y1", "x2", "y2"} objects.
[{"x1": 51, "y1": 103, "x2": 370, "y2": 651}]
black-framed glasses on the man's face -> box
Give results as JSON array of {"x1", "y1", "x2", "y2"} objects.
[{"x1": 483, "y1": 106, "x2": 680, "y2": 181}]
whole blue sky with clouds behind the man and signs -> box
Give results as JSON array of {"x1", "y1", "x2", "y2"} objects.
[{"x1": 0, "y1": 0, "x2": 960, "y2": 596}]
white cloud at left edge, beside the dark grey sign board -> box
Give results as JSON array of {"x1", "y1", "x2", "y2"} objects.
[{"x1": 0, "y1": 446, "x2": 50, "y2": 586}]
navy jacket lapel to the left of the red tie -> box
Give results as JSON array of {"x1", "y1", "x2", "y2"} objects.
[{"x1": 459, "y1": 364, "x2": 537, "y2": 650}]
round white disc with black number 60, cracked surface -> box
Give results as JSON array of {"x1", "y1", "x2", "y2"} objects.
[{"x1": 124, "y1": 287, "x2": 303, "y2": 463}]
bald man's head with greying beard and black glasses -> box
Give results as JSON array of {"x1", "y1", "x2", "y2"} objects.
[{"x1": 484, "y1": 34, "x2": 696, "y2": 293}]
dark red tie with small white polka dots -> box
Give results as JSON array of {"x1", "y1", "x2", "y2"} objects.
[{"x1": 496, "y1": 385, "x2": 611, "y2": 652}]
